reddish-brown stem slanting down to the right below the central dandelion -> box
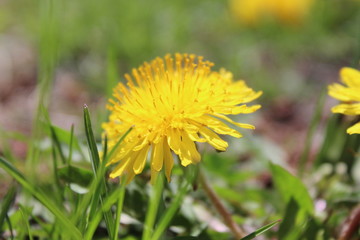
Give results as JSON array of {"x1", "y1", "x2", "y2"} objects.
[{"x1": 199, "y1": 170, "x2": 245, "y2": 239}]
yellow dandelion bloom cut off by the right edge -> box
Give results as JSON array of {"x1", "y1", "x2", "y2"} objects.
[{"x1": 329, "y1": 67, "x2": 360, "y2": 134}]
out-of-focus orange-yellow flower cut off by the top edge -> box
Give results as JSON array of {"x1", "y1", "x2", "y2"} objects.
[{"x1": 230, "y1": 0, "x2": 314, "y2": 25}]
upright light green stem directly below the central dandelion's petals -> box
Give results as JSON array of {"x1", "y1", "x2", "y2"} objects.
[{"x1": 142, "y1": 173, "x2": 164, "y2": 240}]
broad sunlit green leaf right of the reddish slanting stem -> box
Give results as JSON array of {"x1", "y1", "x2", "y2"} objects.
[{"x1": 270, "y1": 163, "x2": 314, "y2": 214}]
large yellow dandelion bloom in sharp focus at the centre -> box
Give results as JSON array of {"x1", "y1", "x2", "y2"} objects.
[{"x1": 103, "y1": 54, "x2": 262, "y2": 181}]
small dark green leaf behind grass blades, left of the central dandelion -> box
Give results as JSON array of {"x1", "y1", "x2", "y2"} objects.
[{"x1": 58, "y1": 165, "x2": 93, "y2": 187}]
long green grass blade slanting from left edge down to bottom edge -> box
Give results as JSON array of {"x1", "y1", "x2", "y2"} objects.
[{"x1": 0, "y1": 157, "x2": 82, "y2": 239}]
